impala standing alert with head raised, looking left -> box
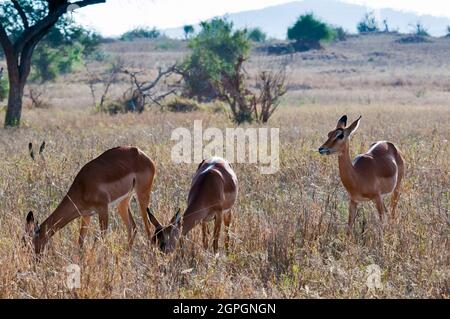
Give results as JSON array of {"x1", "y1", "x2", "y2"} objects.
[{"x1": 319, "y1": 115, "x2": 405, "y2": 230}]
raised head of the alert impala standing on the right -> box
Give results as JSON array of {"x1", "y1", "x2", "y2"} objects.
[{"x1": 319, "y1": 115, "x2": 361, "y2": 155}]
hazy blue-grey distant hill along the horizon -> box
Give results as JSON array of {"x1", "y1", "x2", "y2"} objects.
[{"x1": 163, "y1": 0, "x2": 450, "y2": 39}]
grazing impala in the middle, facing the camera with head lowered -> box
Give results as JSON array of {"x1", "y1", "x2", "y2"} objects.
[{"x1": 147, "y1": 157, "x2": 238, "y2": 253}]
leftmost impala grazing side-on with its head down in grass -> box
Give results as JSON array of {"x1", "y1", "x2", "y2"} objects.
[{"x1": 25, "y1": 147, "x2": 155, "y2": 254}]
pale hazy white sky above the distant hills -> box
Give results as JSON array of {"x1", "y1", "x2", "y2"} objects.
[{"x1": 74, "y1": 0, "x2": 450, "y2": 36}]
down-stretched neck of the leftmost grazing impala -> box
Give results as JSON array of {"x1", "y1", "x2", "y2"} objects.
[{"x1": 35, "y1": 195, "x2": 80, "y2": 253}]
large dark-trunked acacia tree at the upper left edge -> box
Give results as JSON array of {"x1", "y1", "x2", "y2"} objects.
[{"x1": 0, "y1": 0, "x2": 106, "y2": 127}]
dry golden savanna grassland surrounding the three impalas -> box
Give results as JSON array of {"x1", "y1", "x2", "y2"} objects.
[{"x1": 0, "y1": 35, "x2": 450, "y2": 298}]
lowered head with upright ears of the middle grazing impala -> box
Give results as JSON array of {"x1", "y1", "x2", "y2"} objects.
[{"x1": 147, "y1": 208, "x2": 181, "y2": 253}]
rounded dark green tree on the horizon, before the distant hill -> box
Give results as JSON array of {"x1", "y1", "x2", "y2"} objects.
[{"x1": 287, "y1": 13, "x2": 334, "y2": 48}]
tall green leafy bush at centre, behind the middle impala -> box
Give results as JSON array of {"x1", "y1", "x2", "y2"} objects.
[{"x1": 180, "y1": 18, "x2": 250, "y2": 101}]
